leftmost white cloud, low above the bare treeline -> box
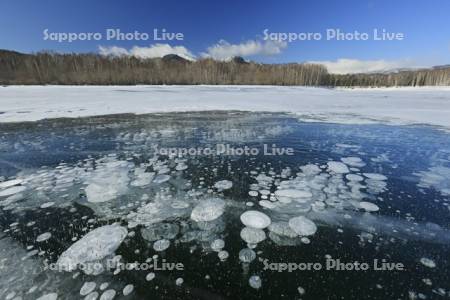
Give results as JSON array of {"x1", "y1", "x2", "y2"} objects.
[{"x1": 99, "y1": 44, "x2": 195, "y2": 60}]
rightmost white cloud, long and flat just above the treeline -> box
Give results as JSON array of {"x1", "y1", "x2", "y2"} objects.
[{"x1": 308, "y1": 58, "x2": 418, "y2": 74}]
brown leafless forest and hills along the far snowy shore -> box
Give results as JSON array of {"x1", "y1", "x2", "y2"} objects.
[{"x1": 0, "y1": 50, "x2": 450, "y2": 87}]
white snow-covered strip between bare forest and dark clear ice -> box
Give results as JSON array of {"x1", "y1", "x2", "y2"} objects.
[{"x1": 0, "y1": 85, "x2": 450, "y2": 129}]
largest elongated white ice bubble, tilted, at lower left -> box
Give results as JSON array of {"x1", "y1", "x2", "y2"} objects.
[{"x1": 57, "y1": 225, "x2": 128, "y2": 271}]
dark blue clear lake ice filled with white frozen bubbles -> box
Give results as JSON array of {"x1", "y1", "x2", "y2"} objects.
[{"x1": 0, "y1": 108, "x2": 450, "y2": 299}]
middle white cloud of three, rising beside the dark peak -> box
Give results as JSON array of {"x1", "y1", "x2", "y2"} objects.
[{"x1": 201, "y1": 40, "x2": 287, "y2": 60}]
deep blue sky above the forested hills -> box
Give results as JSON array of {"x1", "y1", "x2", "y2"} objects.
[{"x1": 0, "y1": 0, "x2": 450, "y2": 72}]
